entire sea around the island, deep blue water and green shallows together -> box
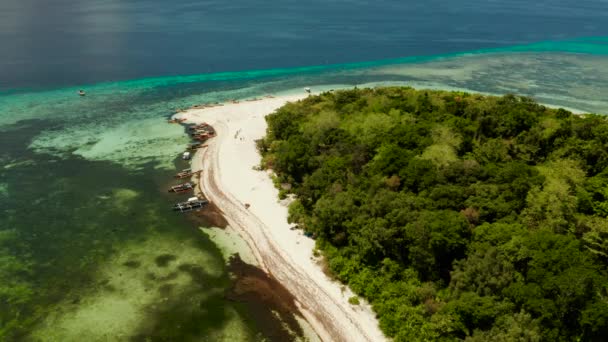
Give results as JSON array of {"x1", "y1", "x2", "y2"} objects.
[{"x1": 0, "y1": 0, "x2": 608, "y2": 341}]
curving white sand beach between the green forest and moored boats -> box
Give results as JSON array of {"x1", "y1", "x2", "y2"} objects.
[{"x1": 175, "y1": 94, "x2": 386, "y2": 342}]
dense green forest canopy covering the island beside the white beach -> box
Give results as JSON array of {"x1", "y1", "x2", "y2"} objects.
[{"x1": 258, "y1": 87, "x2": 608, "y2": 341}]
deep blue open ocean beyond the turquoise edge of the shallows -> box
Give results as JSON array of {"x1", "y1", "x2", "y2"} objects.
[{"x1": 0, "y1": 0, "x2": 608, "y2": 90}]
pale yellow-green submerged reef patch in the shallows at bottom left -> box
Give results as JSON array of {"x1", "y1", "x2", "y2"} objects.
[{"x1": 33, "y1": 233, "x2": 248, "y2": 341}]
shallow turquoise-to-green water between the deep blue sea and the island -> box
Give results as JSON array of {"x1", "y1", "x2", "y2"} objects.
[{"x1": 0, "y1": 37, "x2": 608, "y2": 341}]
